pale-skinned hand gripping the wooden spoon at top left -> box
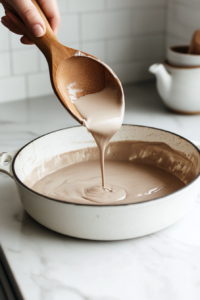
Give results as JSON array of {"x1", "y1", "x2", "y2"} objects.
[{"x1": 0, "y1": 0, "x2": 60, "y2": 45}]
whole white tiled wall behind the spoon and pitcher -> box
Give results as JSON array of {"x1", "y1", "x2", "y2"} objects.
[{"x1": 0, "y1": 0, "x2": 197, "y2": 102}]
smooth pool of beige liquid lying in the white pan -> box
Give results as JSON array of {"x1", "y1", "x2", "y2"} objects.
[{"x1": 32, "y1": 160, "x2": 184, "y2": 204}]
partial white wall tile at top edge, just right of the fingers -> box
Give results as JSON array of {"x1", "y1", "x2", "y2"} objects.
[{"x1": 68, "y1": 0, "x2": 105, "y2": 12}]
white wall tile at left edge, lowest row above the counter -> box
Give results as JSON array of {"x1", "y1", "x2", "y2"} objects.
[{"x1": 0, "y1": 76, "x2": 26, "y2": 103}]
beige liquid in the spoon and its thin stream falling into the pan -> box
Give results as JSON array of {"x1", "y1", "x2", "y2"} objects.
[{"x1": 74, "y1": 88, "x2": 125, "y2": 199}]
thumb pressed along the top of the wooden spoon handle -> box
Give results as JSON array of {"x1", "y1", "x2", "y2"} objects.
[{"x1": 7, "y1": 0, "x2": 46, "y2": 37}]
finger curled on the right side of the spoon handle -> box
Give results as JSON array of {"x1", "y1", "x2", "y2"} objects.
[{"x1": 38, "y1": 0, "x2": 60, "y2": 34}]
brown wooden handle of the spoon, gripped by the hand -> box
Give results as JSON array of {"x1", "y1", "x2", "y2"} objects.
[{"x1": 0, "y1": 0, "x2": 71, "y2": 62}]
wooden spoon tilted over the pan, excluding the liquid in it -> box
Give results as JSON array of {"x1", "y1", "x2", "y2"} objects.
[{"x1": 2, "y1": 0, "x2": 123, "y2": 124}]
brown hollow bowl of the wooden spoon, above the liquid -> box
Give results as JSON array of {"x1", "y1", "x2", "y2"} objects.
[{"x1": 55, "y1": 51, "x2": 123, "y2": 123}]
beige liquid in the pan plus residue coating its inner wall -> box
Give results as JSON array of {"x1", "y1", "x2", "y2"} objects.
[{"x1": 28, "y1": 141, "x2": 191, "y2": 205}]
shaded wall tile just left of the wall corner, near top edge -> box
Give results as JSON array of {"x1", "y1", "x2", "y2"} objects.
[{"x1": 131, "y1": 8, "x2": 165, "y2": 34}]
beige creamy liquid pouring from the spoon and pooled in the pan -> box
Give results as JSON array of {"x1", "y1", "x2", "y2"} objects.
[{"x1": 32, "y1": 59, "x2": 188, "y2": 204}]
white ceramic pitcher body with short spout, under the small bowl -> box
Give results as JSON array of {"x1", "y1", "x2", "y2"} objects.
[{"x1": 149, "y1": 63, "x2": 200, "y2": 114}]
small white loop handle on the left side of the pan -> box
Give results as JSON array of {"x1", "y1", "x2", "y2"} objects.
[{"x1": 0, "y1": 150, "x2": 18, "y2": 178}]
